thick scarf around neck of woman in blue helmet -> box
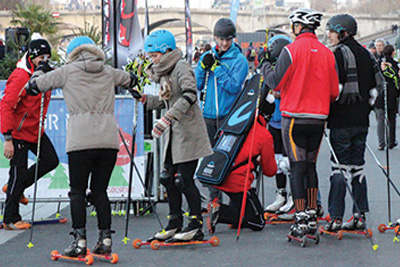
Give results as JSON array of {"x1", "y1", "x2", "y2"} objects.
[{"x1": 145, "y1": 49, "x2": 182, "y2": 100}]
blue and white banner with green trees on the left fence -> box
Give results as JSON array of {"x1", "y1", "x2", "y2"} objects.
[{"x1": 0, "y1": 81, "x2": 145, "y2": 201}]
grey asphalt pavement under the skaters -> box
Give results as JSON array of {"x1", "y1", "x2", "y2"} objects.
[{"x1": 0, "y1": 113, "x2": 400, "y2": 267}]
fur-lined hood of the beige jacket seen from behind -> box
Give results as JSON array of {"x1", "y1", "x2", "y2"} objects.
[{"x1": 67, "y1": 44, "x2": 105, "y2": 73}]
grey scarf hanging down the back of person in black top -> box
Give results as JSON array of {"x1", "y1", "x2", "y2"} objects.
[{"x1": 337, "y1": 44, "x2": 363, "y2": 105}]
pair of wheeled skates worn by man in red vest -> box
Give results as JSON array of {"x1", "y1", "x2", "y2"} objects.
[{"x1": 287, "y1": 211, "x2": 319, "y2": 248}]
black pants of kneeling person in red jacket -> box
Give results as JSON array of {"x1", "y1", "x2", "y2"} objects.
[{"x1": 217, "y1": 188, "x2": 265, "y2": 231}]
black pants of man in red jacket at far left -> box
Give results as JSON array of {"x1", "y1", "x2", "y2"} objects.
[{"x1": 4, "y1": 133, "x2": 59, "y2": 224}]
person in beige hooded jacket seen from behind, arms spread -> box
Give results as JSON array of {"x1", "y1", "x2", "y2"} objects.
[{"x1": 26, "y1": 36, "x2": 137, "y2": 257}]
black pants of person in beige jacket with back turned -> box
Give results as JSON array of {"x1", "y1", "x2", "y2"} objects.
[{"x1": 68, "y1": 149, "x2": 118, "y2": 230}]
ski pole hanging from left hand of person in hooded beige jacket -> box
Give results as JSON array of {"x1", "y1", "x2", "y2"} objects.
[{"x1": 27, "y1": 92, "x2": 46, "y2": 248}]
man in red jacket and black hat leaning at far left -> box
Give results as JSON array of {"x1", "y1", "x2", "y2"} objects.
[{"x1": 0, "y1": 39, "x2": 59, "y2": 230}]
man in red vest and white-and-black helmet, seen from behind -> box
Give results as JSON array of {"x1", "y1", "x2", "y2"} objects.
[{"x1": 262, "y1": 8, "x2": 339, "y2": 240}]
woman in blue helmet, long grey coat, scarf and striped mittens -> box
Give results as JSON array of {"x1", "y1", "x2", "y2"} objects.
[{"x1": 141, "y1": 30, "x2": 212, "y2": 241}]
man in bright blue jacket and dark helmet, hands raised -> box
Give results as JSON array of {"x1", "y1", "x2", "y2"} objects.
[{"x1": 195, "y1": 18, "x2": 249, "y2": 203}]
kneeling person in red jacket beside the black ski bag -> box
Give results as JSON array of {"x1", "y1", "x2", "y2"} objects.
[{"x1": 207, "y1": 92, "x2": 278, "y2": 233}]
